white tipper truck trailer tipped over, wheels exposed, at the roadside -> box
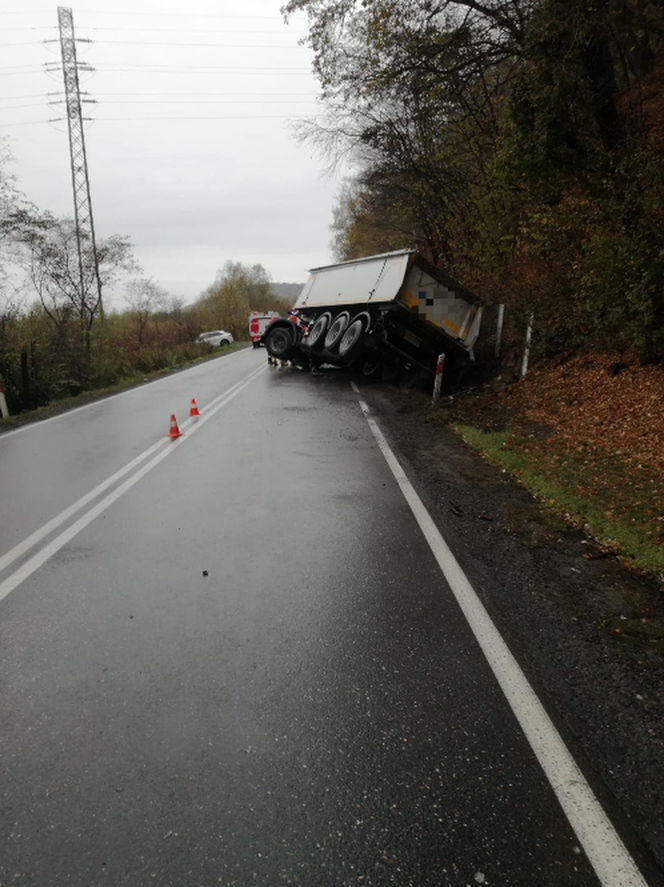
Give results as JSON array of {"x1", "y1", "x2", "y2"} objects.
[{"x1": 262, "y1": 250, "x2": 482, "y2": 381}]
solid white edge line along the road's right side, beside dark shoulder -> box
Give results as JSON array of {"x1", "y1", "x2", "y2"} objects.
[{"x1": 351, "y1": 382, "x2": 648, "y2": 887}]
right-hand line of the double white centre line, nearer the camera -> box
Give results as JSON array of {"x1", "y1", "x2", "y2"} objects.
[{"x1": 0, "y1": 365, "x2": 267, "y2": 601}]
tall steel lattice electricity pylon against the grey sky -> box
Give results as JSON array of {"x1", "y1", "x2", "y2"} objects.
[{"x1": 58, "y1": 6, "x2": 104, "y2": 317}]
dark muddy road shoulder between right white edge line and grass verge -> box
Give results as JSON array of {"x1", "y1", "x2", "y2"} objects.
[{"x1": 362, "y1": 386, "x2": 664, "y2": 880}]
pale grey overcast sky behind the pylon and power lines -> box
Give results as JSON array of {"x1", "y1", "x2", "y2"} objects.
[{"x1": 0, "y1": 0, "x2": 338, "y2": 307}]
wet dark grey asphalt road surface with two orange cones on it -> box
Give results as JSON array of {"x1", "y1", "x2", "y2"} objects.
[{"x1": 0, "y1": 351, "x2": 624, "y2": 887}]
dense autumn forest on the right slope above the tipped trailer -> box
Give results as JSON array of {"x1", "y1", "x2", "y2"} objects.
[{"x1": 282, "y1": 0, "x2": 664, "y2": 362}]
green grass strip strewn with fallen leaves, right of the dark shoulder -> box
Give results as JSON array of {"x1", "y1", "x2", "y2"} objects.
[{"x1": 452, "y1": 425, "x2": 664, "y2": 578}]
